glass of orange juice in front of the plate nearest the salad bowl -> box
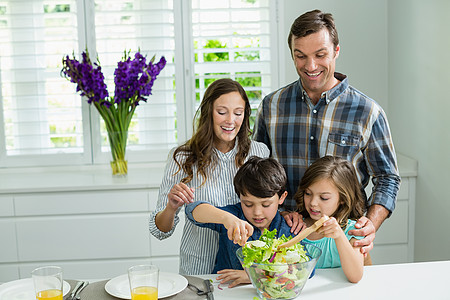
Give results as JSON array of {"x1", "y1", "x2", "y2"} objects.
[{"x1": 128, "y1": 265, "x2": 159, "y2": 300}]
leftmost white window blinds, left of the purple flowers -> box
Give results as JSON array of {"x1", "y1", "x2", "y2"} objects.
[{"x1": 0, "y1": 0, "x2": 86, "y2": 166}]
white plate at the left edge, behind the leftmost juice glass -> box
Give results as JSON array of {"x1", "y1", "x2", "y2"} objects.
[{"x1": 0, "y1": 278, "x2": 70, "y2": 300}]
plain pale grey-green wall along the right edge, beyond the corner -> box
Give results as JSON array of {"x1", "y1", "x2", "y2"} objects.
[{"x1": 388, "y1": 0, "x2": 450, "y2": 261}]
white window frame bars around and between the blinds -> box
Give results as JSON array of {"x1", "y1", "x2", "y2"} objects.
[{"x1": 0, "y1": 0, "x2": 280, "y2": 168}]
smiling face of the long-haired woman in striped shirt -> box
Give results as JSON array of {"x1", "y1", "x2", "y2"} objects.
[{"x1": 213, "y1": 92, "x2": 245, "y2": 153}]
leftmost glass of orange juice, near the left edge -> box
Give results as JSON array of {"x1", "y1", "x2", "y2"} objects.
[{"x1": 31, "y1": 266, "x2": 63, "y2": 300}]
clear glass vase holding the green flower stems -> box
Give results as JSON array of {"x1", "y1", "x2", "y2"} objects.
[{"x1": 108, "y1": 131, "x2": 128, "y2": 176}]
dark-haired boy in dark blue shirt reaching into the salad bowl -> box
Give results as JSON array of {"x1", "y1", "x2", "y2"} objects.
[{"x1": 186, "y1": 156, "x2": 291, "y2": 287}]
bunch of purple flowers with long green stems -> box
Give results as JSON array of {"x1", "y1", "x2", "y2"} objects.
[{"x1": 61, "y1": 52, "x2": 166, "y2": 161}]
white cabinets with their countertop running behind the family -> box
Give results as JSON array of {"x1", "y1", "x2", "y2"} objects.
[{"x1": 0, "y1": 156, "x2": 417, "y2": 282}]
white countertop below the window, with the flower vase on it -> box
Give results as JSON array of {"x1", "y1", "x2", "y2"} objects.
[{"x1": 0, "y1": 154, "x2": 417, "y2": 195}]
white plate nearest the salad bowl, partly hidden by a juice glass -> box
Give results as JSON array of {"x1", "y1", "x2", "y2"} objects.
[{"x1": 105, "y1": 272, "x2": 187, "y2": 299}]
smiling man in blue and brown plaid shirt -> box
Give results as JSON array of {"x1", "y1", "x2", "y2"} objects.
[{"x1": 254, "y1": 10, "x2": 400, "y2": 253}]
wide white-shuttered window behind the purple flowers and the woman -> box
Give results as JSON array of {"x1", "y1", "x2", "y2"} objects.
[{"x1": 0, "y1": 0, "x2": 277, "y2": 167}]
